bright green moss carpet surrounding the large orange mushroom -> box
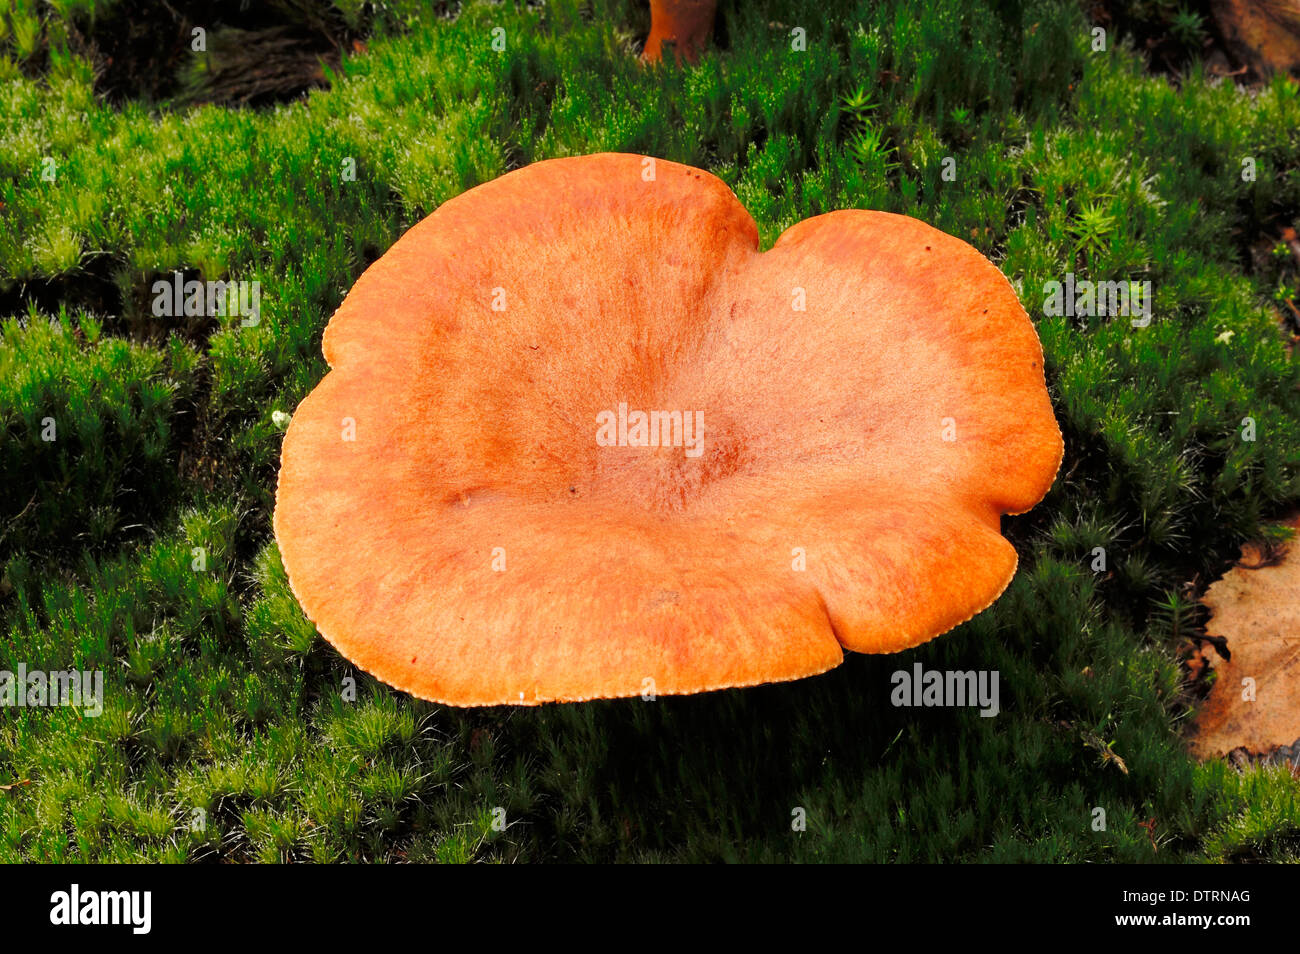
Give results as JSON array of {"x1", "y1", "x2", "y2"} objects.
[{"x1": 0, "y1": 0, "x2": 1300, "y2": 862}]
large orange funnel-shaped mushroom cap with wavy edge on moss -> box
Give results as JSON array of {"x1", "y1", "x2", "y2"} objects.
[{"x1": 274, "y1": 153, "x2": 1062, "y2": 706}]
